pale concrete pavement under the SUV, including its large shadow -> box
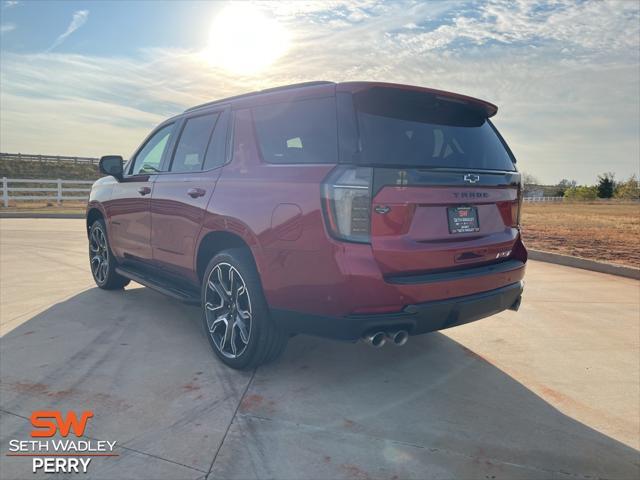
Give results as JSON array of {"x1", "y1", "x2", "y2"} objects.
[{"x1": 0, "y1": 219, "x2": 640, "y2": 480}]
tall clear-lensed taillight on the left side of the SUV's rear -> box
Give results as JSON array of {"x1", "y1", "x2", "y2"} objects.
[{"x1": 322, "y1": 166, "x2": 373, "y2": 243}]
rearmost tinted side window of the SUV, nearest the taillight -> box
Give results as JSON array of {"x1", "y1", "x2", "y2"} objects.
[{"x1": 253, "y1": 97, "x2": 338, "y2": 163}]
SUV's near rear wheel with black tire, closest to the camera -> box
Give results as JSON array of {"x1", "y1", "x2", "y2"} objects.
[{"x1": 202, "y1": 249, "x2": 288, "y2": 370}]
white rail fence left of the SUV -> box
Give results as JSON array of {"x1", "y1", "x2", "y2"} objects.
[{"x1": 2, "y1": 177, "x2": 94, "y2": 208}]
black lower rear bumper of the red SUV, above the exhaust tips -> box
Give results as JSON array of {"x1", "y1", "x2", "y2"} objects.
[{"x1": 272, "y1": 281, "x2": 524, "y2": 341}]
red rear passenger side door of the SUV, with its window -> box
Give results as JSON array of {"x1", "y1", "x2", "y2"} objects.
[{"x1": 151, "y1": 107, "x2": 230, "y2": 281}]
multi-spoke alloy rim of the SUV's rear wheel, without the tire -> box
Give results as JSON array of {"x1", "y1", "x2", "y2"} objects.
[{"x1": 204, "y1": 263, "x2": 252, "y2": 358}]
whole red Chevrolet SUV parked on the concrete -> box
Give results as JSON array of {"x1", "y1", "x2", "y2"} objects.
[{"x1": 87, "y1": 82, "x2": 527, "y2": 369}]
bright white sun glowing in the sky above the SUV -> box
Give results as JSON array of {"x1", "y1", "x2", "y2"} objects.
[{"x1": 207, "y1": 2, "x2": 289, "y2": 75}]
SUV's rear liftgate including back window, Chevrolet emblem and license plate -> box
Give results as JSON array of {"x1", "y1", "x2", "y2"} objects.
[{"x1": 344, "y1": 89, "x2": 520, "y2": 276}]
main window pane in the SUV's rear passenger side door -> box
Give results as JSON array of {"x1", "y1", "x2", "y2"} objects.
[{"x1": 171, "y1": 113, "x2": 219, "y2": 173}]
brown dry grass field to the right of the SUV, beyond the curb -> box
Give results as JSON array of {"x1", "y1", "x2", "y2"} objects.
[{"x1": 522, "y1": 201, "x2": 640, "y2": 267}]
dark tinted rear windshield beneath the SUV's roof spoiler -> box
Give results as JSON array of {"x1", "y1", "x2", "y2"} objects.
[{"x1": 354, "y1": 89, "x2": 514, "y2": 170}]
